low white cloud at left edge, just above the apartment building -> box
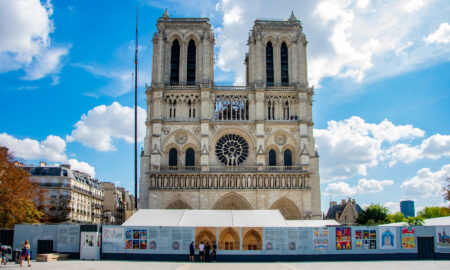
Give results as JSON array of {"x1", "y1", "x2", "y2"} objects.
[{"x1": 0, "y1": 133, "x2": 67, "y2": 162}]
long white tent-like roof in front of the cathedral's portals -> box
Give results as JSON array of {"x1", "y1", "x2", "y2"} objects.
[{"x1": 122, "y1": 209, "x2": 339, "y2": 227}]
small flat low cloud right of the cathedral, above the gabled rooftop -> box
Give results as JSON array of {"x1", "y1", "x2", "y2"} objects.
[{"x1": 325, "y1": 178, "x2": 394, "y2": 196}]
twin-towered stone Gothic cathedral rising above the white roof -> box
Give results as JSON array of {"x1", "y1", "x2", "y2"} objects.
[{"x1": 139, "y1": 11, "x2": 322, "y2": 220}]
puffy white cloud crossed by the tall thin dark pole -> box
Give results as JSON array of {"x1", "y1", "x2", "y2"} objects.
[{"x1": 67, "y1": 102, "x2": 146, "y2": 151}]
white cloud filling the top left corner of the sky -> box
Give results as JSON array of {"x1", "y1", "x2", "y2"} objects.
[{"x1": 0, "y1": 0, "x2": 70, "y2": 81}]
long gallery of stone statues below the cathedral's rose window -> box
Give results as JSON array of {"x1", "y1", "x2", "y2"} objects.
[{"x1": 148, "y1": 171, "x2": 311, "y2": 189}]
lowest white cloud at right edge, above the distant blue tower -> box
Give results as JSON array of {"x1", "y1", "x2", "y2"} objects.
[{"x1": 400, "y1": 164, "x2": 450, "y2": 198}]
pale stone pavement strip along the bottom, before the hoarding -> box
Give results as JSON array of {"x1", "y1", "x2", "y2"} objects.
[{"x1": 0, "y1": 260, "x2": 450, "y2": 270}]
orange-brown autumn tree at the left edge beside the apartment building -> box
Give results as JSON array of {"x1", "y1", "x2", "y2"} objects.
[{"x1": 0, "y1": 147, "x2": 44, "y2": 228}]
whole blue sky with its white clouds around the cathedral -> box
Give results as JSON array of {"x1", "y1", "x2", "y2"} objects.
[{"x1": 0, "y1": 0, "x2": 450, "y2": 215}]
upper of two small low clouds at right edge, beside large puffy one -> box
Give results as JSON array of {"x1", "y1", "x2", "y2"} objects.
[{"x1": 385, "y1": 134, "x2": 450, "y2": 166}]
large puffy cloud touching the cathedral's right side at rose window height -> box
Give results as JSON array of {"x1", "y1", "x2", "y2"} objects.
[{"x1": 314, "y1": 116, "x2": 424, "y2": 182}]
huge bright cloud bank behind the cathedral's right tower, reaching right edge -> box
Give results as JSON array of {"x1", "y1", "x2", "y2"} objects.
[{"x1": 216, "y1": 0, "x2": 450, "y2": 85}]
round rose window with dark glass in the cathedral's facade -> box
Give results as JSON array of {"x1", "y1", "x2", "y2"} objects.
[{"x1": 216, "y1": 134, "x2": 248, "y2": 166}]
